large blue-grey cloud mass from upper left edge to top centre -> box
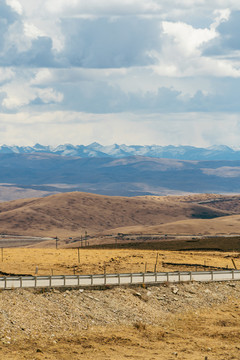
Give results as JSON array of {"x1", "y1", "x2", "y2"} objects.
[{"x1": 0, "y1": 6, "x2": 161, "y2": 68}]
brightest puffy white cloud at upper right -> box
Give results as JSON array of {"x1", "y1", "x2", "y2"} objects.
[{"x1": 151, "y1": 9, "x2": 240, "y2": 78}]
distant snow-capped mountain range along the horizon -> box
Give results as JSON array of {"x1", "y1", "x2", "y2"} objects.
[{"x1": 0, "y1": 142, "x2": 240, "y2": 160}]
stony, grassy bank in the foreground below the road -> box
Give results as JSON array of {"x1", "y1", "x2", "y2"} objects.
[{"x1": 0, "y1": 282, "x2": 240, "y2": 360}]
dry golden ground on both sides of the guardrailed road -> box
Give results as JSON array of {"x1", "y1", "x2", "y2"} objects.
[{"x1": 0, "y1": 248, "x2": 240, "y2": 360}]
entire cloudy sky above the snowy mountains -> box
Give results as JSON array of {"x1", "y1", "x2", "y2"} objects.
[{"x1": 0, "y1": 0, "x2": 240, "y2": 148}]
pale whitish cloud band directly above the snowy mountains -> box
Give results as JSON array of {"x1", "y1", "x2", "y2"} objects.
[{"x1": 0, "y1": 111, "x2": 240, "y2": 147}]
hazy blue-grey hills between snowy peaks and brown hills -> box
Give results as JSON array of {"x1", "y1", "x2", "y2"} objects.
[{"x1": 0, "y1": 153, "x2": 240, "y2": 200}]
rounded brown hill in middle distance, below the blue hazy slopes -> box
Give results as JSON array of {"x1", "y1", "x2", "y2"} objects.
[{"x1": 0, "y1": 192, "x2": 230, "y2": 237}]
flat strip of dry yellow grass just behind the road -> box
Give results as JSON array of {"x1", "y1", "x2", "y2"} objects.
[{"x1": 0, "y1": 248, "x2": 240, "y2": 275}]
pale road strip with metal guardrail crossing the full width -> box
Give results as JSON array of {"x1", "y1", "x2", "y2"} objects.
[{"x1": 0, "y1": 270, "x2": 240, "y2": 290}]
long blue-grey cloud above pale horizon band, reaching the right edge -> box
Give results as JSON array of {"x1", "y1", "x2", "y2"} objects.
[{"x1": 46, "y1": 78, "x2": 240, "y2": 113}]
